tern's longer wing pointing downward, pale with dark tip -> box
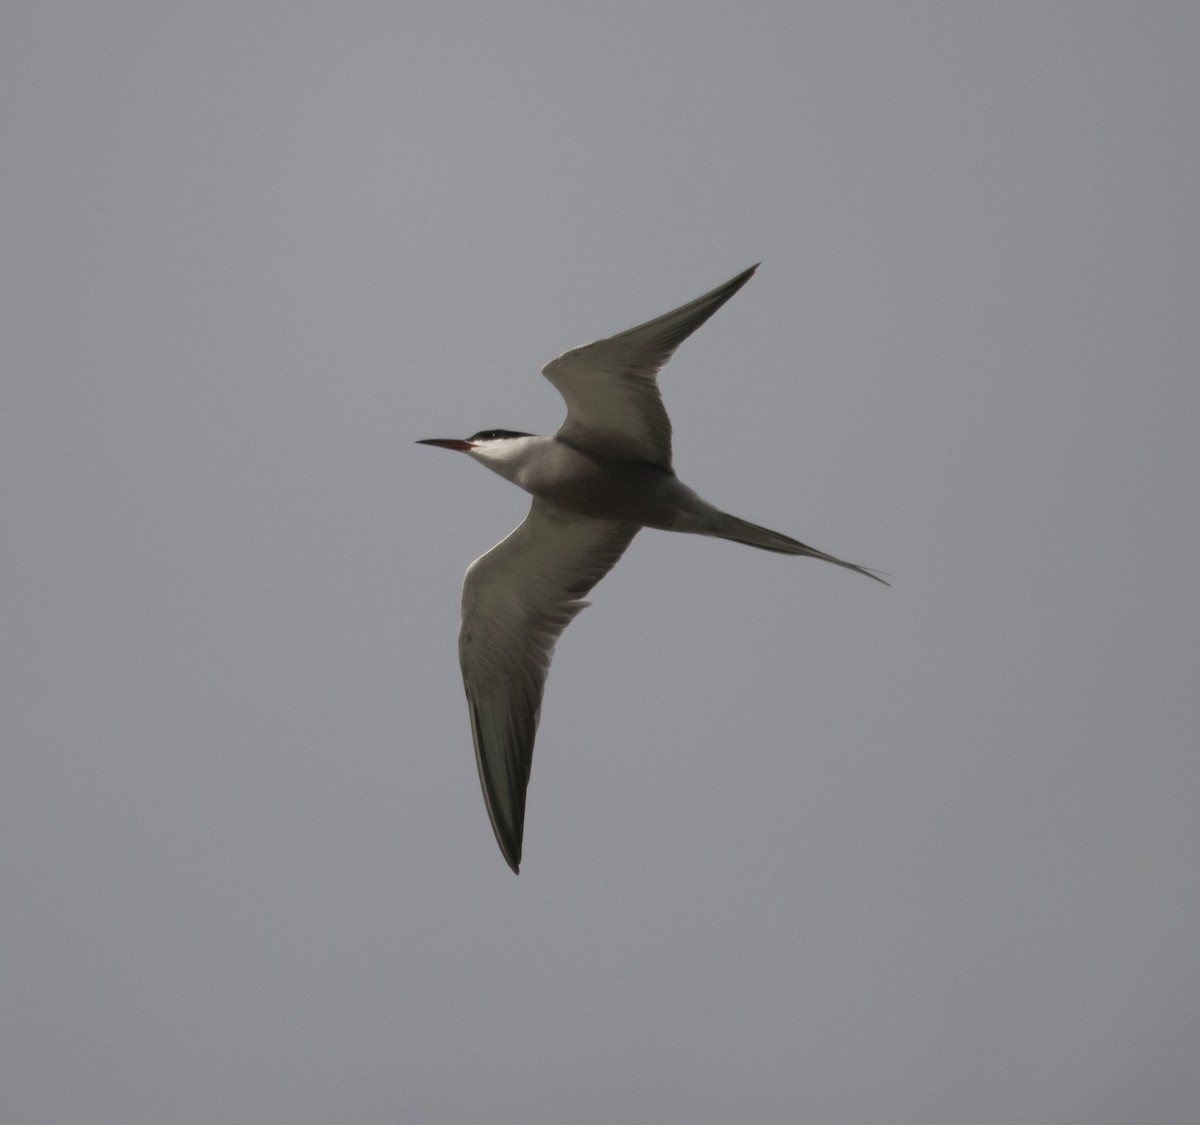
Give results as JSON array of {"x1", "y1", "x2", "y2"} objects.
[{"x1": 458, "y1": 499, "x2": 638, "y2": 871}]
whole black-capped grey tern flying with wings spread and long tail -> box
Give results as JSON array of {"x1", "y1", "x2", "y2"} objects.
[{"x1": 418, "y1": 265, "x2": 888, "y2": 872}]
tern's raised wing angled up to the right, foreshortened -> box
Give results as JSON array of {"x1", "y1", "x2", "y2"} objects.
[{"x1": 541, "y1": 265, "x2": 758, "y2": 469}]
